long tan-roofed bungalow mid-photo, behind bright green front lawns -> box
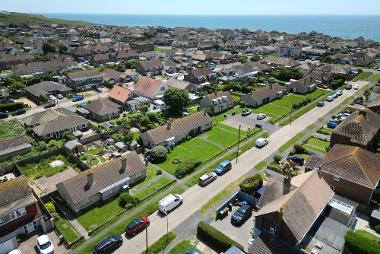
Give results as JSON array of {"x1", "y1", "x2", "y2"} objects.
[{"x1": 141, "y1": 111, "x2": 212, "y2": 148}]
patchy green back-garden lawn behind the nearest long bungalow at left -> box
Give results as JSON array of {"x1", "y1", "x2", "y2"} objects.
[{"x1": 20, "y1": 154, "x2": 79, "y2": 179}]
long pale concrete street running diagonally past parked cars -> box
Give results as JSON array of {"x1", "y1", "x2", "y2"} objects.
[{"x1": 115, "y1": 83, "x2": 364, "y2": 254}]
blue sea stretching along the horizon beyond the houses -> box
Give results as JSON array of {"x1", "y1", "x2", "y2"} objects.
[{"x1": 43, "y1": 13, "x2": 380, "y2": 41}]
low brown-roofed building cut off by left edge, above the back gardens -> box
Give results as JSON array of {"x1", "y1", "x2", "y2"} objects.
[{"x1": 0, "y1": 136, "x2": 32, "y2": 161}]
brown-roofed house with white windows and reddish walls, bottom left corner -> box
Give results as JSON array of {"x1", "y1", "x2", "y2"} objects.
[{"x1": 0, "y1": 176, "x2": 42, "y2": 253}]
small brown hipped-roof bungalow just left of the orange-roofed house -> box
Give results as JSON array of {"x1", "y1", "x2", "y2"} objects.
[{"x1": 84, "y1": 98, "x2": 122, "y2": 122}]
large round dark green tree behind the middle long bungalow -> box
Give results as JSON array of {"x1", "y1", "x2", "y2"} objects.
[{"x1": 164, "y1": 88, "x2": 191, "y2": 113}]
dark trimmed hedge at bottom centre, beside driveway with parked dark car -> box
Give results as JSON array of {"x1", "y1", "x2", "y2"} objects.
[{"x1": 197, "y1": 221, "x2": 244, "y2": 252}]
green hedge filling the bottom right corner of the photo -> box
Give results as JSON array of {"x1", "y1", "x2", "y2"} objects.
[{"x1": 344, "y1": 230, "x2": 380, "y2": 254}]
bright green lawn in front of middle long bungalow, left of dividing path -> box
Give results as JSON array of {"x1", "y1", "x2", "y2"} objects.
[{"x1": 158, "y1": 138, "x2": 223, "y2": 175}]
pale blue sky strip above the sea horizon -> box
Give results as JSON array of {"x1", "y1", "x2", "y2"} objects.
[{"x1": 0, "y1": 0, "x2": 380, "y2": 15}]
